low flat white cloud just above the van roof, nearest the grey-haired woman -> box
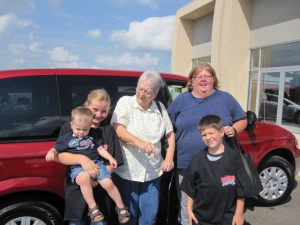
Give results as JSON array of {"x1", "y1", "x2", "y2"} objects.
[{"x1": 96, "y1": 52, "x2": 159, "y2": 68}]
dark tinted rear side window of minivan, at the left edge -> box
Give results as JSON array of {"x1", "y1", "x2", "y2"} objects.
[{"x1": 0, "y1": 76, "x2": 60, "y2": 141}]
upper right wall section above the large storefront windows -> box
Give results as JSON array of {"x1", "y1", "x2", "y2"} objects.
[{"x1": 249, "y1": 0, "x2": 300, "y2": 48}]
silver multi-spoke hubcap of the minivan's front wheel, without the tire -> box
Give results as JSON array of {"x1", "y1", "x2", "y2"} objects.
[{"x1": 259, "y1": 167, "x2": 288, "y2": 200}]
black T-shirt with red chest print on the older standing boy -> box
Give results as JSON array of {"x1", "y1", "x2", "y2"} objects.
[{"x1": 181, "y1": 144, "x2": 252, "y2": 225}]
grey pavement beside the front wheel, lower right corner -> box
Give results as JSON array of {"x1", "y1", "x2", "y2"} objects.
[{"x1": 245, "y1": 177, "x2": 300, "y2": 225}]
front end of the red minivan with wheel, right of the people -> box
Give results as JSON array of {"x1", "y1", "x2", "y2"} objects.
[{"x1": 238, "y1": 112, "x2": 300, "y2": 206}]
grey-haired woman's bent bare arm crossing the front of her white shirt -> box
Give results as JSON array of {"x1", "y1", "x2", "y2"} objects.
[{"x1": 114, "y1": 123, "x2": 155, "y2": 155}]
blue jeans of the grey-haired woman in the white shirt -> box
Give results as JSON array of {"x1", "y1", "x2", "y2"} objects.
[{"x1": 114, "y1": 175, "x2": 160, "y2": 225}]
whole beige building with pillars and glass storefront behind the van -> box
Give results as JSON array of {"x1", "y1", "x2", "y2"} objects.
[{"x1": 172, "y1": 0, "x2": 300, "y2": 134}]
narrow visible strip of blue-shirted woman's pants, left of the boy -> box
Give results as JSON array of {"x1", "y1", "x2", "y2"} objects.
[{"x1": 176, "y1": 169, "x2": 189, "y2": 225}]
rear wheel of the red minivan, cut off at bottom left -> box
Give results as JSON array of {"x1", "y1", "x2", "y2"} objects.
[{"x1": 0, "y1": 201, "x2": 64, "y2": 225}]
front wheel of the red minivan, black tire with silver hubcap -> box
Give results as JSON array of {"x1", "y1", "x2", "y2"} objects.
[{"x1": 259, "y1": 156, "x2": 295, "y2": 206}]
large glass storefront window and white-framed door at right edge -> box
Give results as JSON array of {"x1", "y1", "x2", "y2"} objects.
[{"x1": 248, "y1": 42, "x2": 300, "y2": 133}]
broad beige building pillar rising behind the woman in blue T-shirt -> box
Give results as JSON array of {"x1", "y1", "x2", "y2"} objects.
[{"x1": 212, "y1": 0, "x2": 251, "y2": 110}]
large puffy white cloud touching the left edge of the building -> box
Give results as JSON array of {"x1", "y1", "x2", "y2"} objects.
[{"x1": 110, "y1": 16, "x2": 175, "y2": 51}]
